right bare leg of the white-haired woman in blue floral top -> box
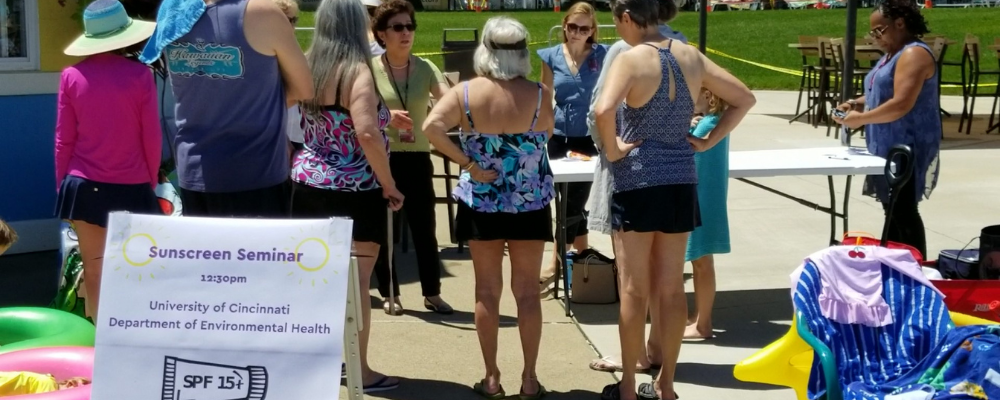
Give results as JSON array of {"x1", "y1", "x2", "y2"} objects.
[{"x1": 507, "y1": 240, "x2": 545, "y2": 395}]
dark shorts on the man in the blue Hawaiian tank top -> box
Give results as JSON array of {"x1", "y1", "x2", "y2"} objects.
[{"x1": 180, "y1": 180, "x2": 292, "y2": 218}]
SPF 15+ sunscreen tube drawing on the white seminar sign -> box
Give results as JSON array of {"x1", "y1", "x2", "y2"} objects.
[{"x1": 161, "y1": 356, "x2": 267, "y2": 400}]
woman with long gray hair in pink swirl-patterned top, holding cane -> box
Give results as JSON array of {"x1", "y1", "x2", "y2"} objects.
[{"x1": 292, "y1": 0, "x2": 403, "y2": 393}]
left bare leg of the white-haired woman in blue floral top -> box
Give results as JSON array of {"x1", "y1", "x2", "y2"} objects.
[{"x1": 469, "y1": 240, "x2": 504, "y2": 393}]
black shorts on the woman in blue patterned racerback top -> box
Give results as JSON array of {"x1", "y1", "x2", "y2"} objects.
[{"x1": 611, "y1": 184, "x2": 701, "y2": 233}]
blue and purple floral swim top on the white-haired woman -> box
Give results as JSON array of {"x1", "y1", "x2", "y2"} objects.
[{"x1": 452, "y1": 82, "x2": 555, "y2": 214}]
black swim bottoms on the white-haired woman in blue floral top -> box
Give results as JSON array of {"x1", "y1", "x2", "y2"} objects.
[{"x1": 455, "y1": 201, "x2": 552, "y2": 242}]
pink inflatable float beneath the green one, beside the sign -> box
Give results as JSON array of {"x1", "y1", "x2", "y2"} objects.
[{"x1": 0, "y1": 347, "x2": 94, "y2": 400}]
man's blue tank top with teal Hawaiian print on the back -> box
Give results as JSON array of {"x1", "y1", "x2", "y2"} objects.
[{"x1": 164, "y1": 0, "x2": 289, "y2": 192}]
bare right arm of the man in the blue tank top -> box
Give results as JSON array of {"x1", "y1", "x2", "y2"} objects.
[{"x1": 244, "y1": 0, "x2": 316, "y2": 106}]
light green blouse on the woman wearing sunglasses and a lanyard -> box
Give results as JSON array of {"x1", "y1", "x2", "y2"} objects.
[{"x1": 372, "y1": 56, "x2": 447, "y2": 152}]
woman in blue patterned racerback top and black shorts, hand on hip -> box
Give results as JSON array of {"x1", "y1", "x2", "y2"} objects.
[{"x1": 595, "y1": 0, "x2": 756, "y2": 400}]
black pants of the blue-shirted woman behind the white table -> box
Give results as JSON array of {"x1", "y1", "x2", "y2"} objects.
[{"x1": 546, "y1": 135, "x2": 600, "y2": 241}]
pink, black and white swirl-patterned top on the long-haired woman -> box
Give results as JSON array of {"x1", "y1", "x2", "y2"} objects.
[{"x1": 292, "y1": 81, "x2": 391, "y2": 192}]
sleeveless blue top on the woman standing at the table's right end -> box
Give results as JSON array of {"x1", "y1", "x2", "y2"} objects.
[{"x1": 863, "y1": 41, "x2": 941, "y2": 203}]
